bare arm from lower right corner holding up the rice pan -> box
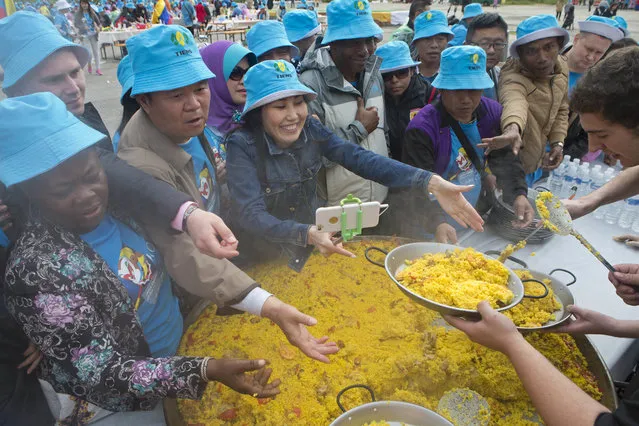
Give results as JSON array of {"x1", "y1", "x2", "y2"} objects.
[{"x1": 445, "y1": 302, "x2": 610, "y2": 426}]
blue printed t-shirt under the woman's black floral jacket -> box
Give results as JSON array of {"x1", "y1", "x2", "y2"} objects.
[{"x1": 81, "y1": 214, "x2": 183, "y2": 357}]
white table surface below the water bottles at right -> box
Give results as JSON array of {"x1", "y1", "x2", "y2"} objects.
[{"x1": 459, "y1": 214, "x2": 639, "y2": 380}]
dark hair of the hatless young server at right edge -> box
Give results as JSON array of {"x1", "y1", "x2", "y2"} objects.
[{"x1": 570, "y1": 45, "x2": 639, "y2": 133}]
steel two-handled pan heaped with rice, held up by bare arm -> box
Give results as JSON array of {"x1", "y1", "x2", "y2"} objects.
[{"x1": 366, "y1": 243, "x2": 547, "y2": 318}]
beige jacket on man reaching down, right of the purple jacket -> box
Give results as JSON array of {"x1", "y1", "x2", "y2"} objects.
[{"x1": 499, "y1": 57, "x2": 568, "y2": 173}]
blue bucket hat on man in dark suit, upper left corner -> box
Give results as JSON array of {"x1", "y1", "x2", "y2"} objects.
[{"x1": 0, "y1": 12, "x2": 89, "y2": 89}]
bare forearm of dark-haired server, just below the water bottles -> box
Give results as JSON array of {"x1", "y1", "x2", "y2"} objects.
[{"x1": 563, "y1": 166, "x2": 639, "y2": 219}]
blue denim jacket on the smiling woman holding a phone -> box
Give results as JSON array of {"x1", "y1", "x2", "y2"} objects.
[{"x1": 227, "y1": 118, "x2": 432, "y2": 253}]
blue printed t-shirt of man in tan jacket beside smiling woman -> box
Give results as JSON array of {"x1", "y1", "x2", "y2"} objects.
[{"x1": 180, "y1": 128, "x2": 226, "y2": 214}]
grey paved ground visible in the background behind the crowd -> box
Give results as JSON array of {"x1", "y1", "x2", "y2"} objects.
[{"x1": 6, "y1": 3, "x2": 639, "y2": 133}]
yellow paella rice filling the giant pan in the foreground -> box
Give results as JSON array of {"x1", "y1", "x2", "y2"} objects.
[{"x1": 178, "y1": 242, "x2": 601, "y2": 426}]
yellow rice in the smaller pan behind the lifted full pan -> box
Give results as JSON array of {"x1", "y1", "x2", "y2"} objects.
[{"x1": 503, "y1": 269, "x2": 561, "y2": 328}]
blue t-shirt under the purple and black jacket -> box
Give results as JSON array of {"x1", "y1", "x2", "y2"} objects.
[{"x1": 444, "y1": 120, "x2": 484, "y2": 225}]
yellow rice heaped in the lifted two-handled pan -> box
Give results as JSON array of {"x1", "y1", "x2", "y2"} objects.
[{"x1": 396, "y1": 248, "x2": 514, "y2": 309}]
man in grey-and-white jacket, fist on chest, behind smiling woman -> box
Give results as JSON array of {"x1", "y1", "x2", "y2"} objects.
[{"x1": 300, "y1": 0, "x2": 388, "y2": 206}]
